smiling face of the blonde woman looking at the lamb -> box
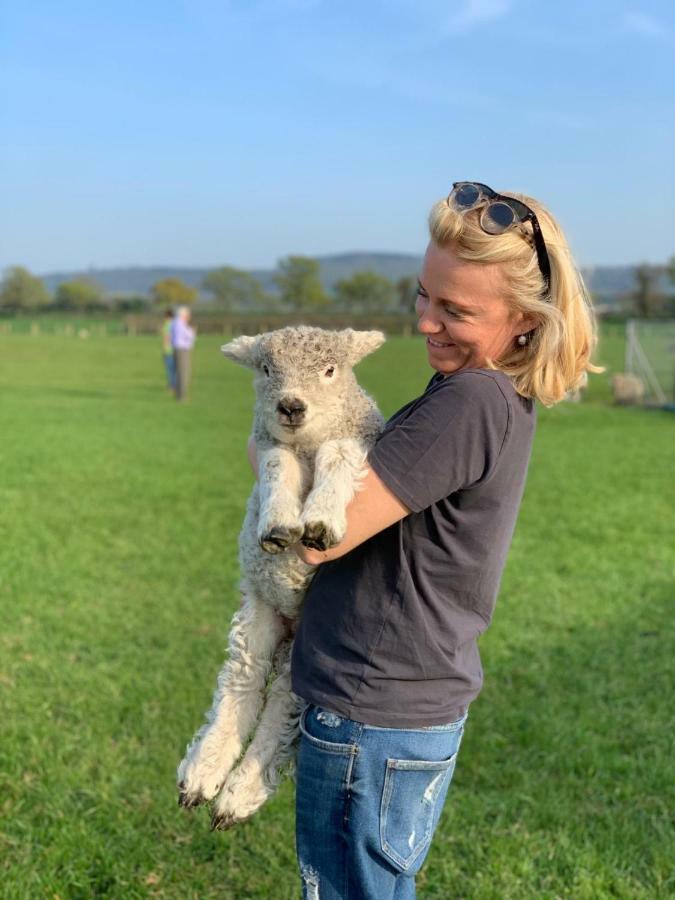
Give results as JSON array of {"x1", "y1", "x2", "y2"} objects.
[{"x1": 415, "y1": 241, "x2": 533, "y2": 375}]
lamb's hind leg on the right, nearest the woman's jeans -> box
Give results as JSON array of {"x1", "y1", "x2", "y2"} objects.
[{"x1": 213, "y1": 641, "x2": 301, "y2": 830}]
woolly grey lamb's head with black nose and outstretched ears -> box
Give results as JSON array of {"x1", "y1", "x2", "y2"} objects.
[{"x1": 222, "y1": 325, "x2": 384, "y2": 443}]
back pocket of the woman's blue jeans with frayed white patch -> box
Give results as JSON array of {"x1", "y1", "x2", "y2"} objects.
[{"x1": 380, "y1": 753, "x2": 457, "y2": 872}]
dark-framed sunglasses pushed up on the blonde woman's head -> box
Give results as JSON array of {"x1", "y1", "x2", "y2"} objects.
[{"x1": 448, "y1": 181, "x2": 551, "y2": 290}]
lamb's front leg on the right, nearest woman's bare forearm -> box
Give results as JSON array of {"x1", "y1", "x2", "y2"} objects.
[{"x1": 301, "y1": 438, "x2": 366, "y2": 550}]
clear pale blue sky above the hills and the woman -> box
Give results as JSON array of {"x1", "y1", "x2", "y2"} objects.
[{"x1": 0, "y1": 0, "x2": 675, "y2": 273}]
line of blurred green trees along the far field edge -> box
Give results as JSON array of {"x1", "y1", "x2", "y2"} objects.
[{"x1": 0, "y1": 256, "x2": 675, "y2": 318}]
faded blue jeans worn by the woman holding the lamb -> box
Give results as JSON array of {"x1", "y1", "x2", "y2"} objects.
[{"x1": 296, "y1": 704, "x2": 466, "y2": 900}]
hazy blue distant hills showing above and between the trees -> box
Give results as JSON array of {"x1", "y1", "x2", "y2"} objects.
[{"x1": 42, "y1": 253, "x2": 669, "y2": 299}]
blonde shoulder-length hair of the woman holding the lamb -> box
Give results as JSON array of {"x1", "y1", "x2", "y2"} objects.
[{"x1": 429, "y1": 193, "x2": 604, "y2": 406}]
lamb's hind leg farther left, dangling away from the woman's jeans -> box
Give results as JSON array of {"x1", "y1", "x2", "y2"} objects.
[{"x1": 178, "y1": 594, "x2": 284, "y2": 808}]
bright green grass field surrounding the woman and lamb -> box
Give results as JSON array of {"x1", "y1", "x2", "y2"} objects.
[{"x1": 0, "y1": 326, "x2": 675, "y2": 900}]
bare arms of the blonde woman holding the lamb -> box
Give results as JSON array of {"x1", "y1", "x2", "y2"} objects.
[{"x1": 247, "y1": 437, "x2": 410, "y2": 566}]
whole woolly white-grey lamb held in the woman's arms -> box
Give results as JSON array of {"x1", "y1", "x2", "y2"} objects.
[{"x1": 178, "y1": 325, "x2": 384, "y2": 829}]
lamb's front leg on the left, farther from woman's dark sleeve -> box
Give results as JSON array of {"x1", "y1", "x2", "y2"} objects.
[{"x1": 258, "y1": 447, "x2": 309, "y2": 553}]
